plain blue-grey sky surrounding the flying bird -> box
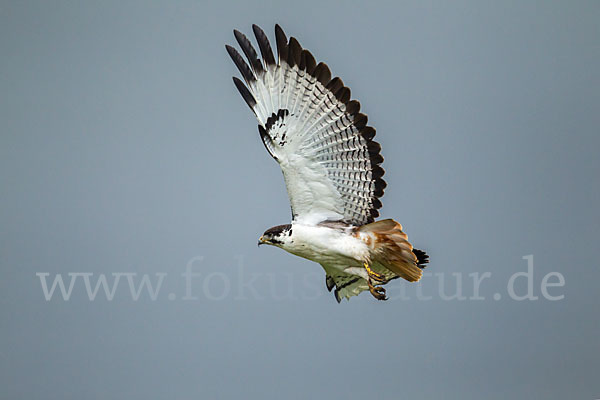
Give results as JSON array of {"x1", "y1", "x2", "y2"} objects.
[{"x1": 0, "y1": 0, "x2": 600, "y2": 400}]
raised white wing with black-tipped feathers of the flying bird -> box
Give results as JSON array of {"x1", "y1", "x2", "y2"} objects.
[{"x1": 226, "y1": 25, "x2": 386, "y2": 225}]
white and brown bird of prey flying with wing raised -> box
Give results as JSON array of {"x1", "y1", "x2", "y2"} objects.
[{"x1": 225, "y1": 25, "x2": 429, "y2": 302}]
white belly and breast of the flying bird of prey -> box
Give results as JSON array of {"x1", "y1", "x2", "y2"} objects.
[{"x1": 279, "y1": 223, "x2": 369, "y2": 279}]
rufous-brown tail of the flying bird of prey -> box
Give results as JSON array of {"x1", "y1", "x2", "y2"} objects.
[{"x1": 359, "y1": 219, "x2": 429, "y2": 282}]
